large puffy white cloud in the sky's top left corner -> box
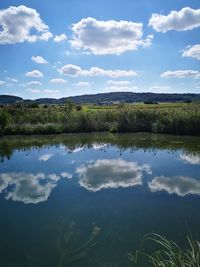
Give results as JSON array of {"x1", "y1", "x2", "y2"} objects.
[{"x1": 0, "y1": 5, "x2": 52, "y2": 44}]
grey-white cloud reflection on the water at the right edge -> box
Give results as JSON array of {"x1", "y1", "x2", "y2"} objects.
[{"x1": 148, "y1": 176, "x2": 200, "y2": 196}]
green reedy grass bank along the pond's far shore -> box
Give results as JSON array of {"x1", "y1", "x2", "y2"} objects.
[{"x1": 0, "y1": 103, "x2": 200, "y2": 135}]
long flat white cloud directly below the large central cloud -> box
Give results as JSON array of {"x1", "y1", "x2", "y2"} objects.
[{"x1": 58, "y1": 64, "x2": 138, "y2": 78}]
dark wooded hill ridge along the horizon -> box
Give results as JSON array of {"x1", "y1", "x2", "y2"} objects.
[{"x1": 0, "y1": 92, "x2": 200, "y2": 104}]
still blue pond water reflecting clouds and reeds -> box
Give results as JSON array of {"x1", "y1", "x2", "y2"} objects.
[{"x1": 0, "y1": 134, "x2": 200, "y2": 267}]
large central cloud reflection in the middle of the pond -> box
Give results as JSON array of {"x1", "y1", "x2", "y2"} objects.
[{"x1": 76, "y1": 159, "x2": 151, "y2": 192}]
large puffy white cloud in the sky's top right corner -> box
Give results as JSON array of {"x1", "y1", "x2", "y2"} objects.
[{"x1": 149, "y1": 7, "x2": 200, "y2": 33}]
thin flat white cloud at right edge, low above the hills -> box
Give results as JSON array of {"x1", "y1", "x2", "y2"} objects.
[{"x1": 160, "y1": 70, "x2": 200, "y2": 78}]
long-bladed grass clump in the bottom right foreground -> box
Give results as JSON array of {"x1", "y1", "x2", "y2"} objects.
[{"x1": 130, "y1": 233, "x2": 200, "y2": 267}]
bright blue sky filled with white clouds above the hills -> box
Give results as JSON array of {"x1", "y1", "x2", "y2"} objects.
[{"x1": 0, "y1": 0, "x2": 200, "y2": 99}]
